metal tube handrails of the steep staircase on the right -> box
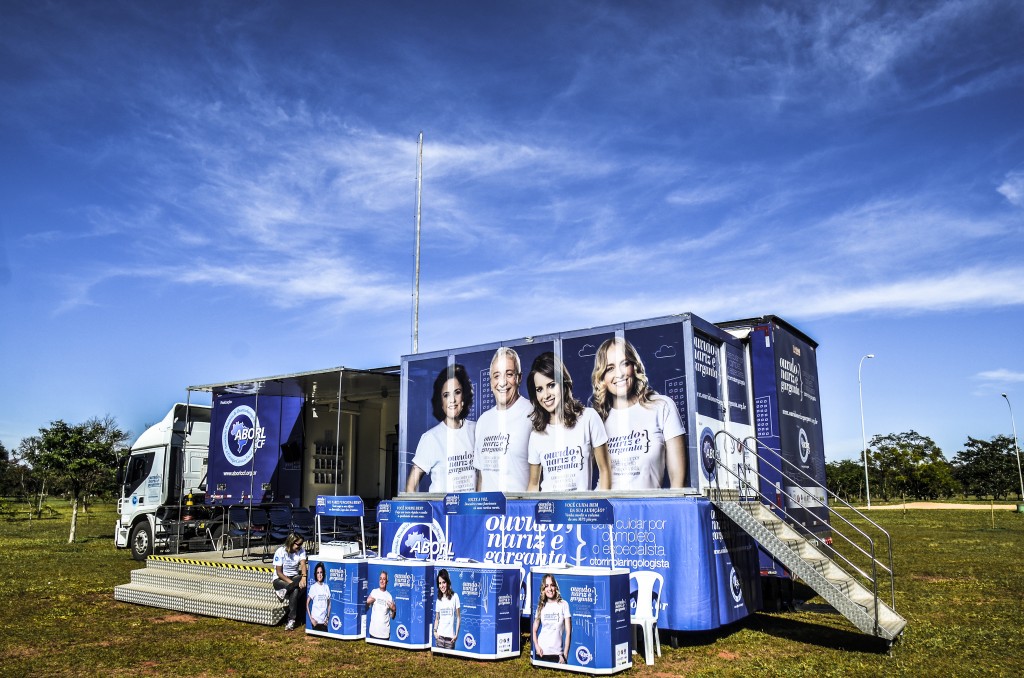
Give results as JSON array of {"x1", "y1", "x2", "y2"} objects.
[{"x1": 715, "y1": 429, "x2": 896, "y2": 623}]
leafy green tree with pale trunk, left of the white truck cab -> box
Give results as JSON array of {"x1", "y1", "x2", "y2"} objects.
[{"x1": 36, "y1": 416, "x2": 128, "y2": 544}]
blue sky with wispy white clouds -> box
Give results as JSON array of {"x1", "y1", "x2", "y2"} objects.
[{"x1": 0, "y1": 0, "x2": 1024, "y2": 461}]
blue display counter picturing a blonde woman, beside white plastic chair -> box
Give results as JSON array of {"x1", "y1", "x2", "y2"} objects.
[{"x1": 529, "y1": 567, "x2": 633, "y2": 675}]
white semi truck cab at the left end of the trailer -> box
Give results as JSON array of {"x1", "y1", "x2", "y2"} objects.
[{"x1": 114, "y1": 402, "x2": 211, "y2": 560}]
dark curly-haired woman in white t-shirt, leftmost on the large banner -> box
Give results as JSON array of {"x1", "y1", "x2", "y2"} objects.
[{"x1": 406, "y1": 365, "x2": 476, "y2": 493}]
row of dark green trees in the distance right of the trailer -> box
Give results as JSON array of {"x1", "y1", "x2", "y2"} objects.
[{"x1": 825, "y1": 430, "x2": 1024, "y2": 503}]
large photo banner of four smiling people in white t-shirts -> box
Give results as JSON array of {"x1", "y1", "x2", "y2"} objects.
[{"x1": 399, "y1": 320, "x2": 696, "y2": 494}]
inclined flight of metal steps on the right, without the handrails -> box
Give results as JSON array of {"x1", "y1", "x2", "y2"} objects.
[{"x1": 712, "y1": 498, "x2": 906, "y2": 641}]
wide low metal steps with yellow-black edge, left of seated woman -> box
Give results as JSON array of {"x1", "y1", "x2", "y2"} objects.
[{"x1": 114, "y1": 553, "x2": 288, "y2": 626}]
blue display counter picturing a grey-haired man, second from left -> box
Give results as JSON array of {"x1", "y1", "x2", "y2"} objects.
[{"x1": 364, "y1": 558, "x2": 434, "y2": 649}]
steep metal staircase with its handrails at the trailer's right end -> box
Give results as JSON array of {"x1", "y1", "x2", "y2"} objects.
[{"x1": 710, "y1": 431, "x2": 906, "y2": 644}]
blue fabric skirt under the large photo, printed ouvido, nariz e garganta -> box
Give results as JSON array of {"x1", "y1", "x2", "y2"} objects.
[{"x1": 381, "y1": 498, "x2": 761, "y2": 631}]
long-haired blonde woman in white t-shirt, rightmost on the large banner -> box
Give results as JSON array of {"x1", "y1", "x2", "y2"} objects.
[{"x1": 591, "y1": 338, "x2": 686, "y2": 490}]
